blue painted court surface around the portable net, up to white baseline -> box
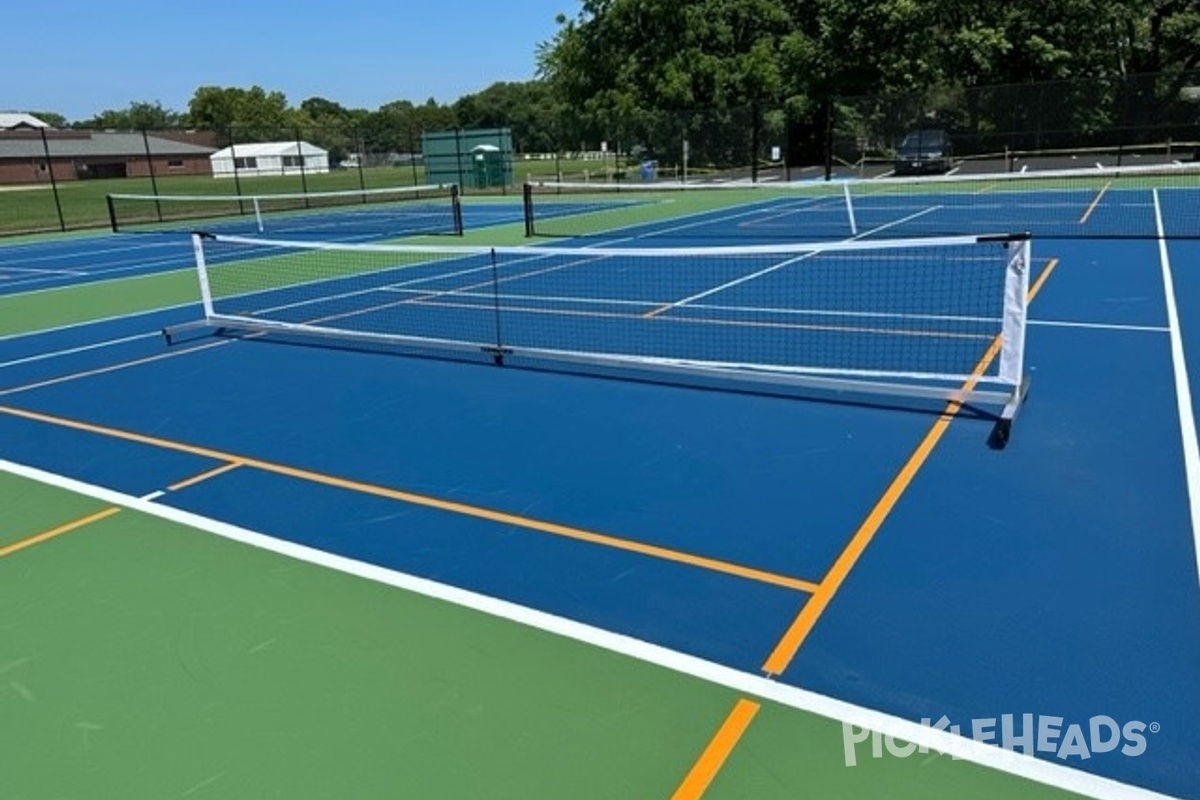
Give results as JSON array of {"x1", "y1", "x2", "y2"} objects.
[{"x1": 0, "y1": 183, "x2": 1200, "y2": 799}]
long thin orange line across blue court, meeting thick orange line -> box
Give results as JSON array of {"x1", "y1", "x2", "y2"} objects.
[{"x1": 0, "y1": 405, "x2": 817, "y2": 593}]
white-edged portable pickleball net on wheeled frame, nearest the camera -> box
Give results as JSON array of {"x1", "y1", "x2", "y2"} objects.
[{"x1": 175, "y1": 234, "x2": 1031, "y2": 431}]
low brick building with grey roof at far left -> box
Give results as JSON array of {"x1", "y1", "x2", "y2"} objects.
[{"x1": 0, "y1": 128, "x2": 214, "y2": 184}]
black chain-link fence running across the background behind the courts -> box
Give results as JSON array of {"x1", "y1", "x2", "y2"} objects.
[{"x1": 0, "y1": 72, "x2": 1200, "y2": 234}]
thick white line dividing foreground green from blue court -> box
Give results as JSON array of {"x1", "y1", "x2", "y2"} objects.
[{"x1": 0, "y1": 459, "x2": 1172, "y2": 800}]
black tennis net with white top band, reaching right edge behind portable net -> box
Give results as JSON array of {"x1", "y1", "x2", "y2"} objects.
[{"x1": 524, "y1": 162, "x2": 1200, "y2": 241}]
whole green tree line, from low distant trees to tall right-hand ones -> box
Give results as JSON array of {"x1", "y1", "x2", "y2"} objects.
[{"x1": 25, "y1": 0, "x2": 1200, "y2": 165}]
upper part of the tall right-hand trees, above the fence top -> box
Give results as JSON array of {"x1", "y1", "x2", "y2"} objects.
[{"x1": 538, "y1": 0, "x2": 1200, "y2": 109}]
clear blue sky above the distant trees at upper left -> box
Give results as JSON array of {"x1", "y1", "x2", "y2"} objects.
[{"x1": 0, "y1": 0, "x2": 581, "y2": 121}]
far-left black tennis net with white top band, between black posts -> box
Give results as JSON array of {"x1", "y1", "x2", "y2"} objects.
[{"x1": 108, "y1": 184, "x2": 462, "y2": 240}]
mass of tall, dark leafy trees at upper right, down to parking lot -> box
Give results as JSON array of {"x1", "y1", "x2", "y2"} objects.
[{"x1": 536, "y1": 0, "x2": 1200, "y2": 161}]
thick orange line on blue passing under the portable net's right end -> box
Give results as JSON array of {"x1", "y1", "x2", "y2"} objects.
[{"x1": 762, "y1": 258, "x2": 1058, "y2": 675}]
